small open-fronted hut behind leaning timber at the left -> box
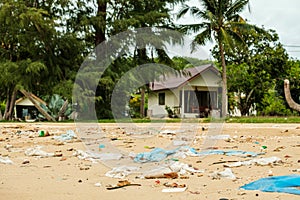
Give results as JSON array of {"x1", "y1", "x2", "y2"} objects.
[{"x1": 15, "y1": 94, "x2": 47, "y2": 120}]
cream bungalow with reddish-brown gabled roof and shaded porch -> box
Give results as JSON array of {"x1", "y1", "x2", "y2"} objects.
[{"x1": 148, "y1": 64, "x2": 221, "y2": 118}]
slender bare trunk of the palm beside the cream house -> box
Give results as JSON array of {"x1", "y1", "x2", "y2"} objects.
[{"x1": 219, "y1": 39, "x2": 228, "y2": 117}]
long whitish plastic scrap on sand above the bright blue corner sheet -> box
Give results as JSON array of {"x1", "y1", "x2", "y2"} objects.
[{"x1": 224, "y1": 156, "x2": 282, "y2": 167}]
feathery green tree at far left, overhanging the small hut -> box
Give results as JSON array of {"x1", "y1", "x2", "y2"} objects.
[{"x1": 0, "y1": 0, "x2": 89, "y2": 119}]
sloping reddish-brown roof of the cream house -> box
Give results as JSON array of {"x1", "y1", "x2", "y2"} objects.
[{"x1": 150, "y1": 64, "x2": 219, "y2": 91}]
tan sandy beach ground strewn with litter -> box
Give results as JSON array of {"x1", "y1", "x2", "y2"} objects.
[{"x1": 0, "y1": 123, "x2": 300, "y2": 200}]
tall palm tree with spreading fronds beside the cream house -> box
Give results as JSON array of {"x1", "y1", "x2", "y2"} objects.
[{"x1": 178, "y1": 0, "x2": 257, "y2": 117}]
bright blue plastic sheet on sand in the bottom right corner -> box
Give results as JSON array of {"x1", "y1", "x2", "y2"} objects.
[{"x1": 241, "y1": 175, "x2": 300, "y2": 195}]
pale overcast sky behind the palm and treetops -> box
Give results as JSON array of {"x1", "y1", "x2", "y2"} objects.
[{"x1": 178, "y1": 0, "x2": 300, "y2": 59}]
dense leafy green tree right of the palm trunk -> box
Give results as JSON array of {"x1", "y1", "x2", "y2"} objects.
[{"x1": 218, "y1": 29, "x2": 290, "y2": 115}]
